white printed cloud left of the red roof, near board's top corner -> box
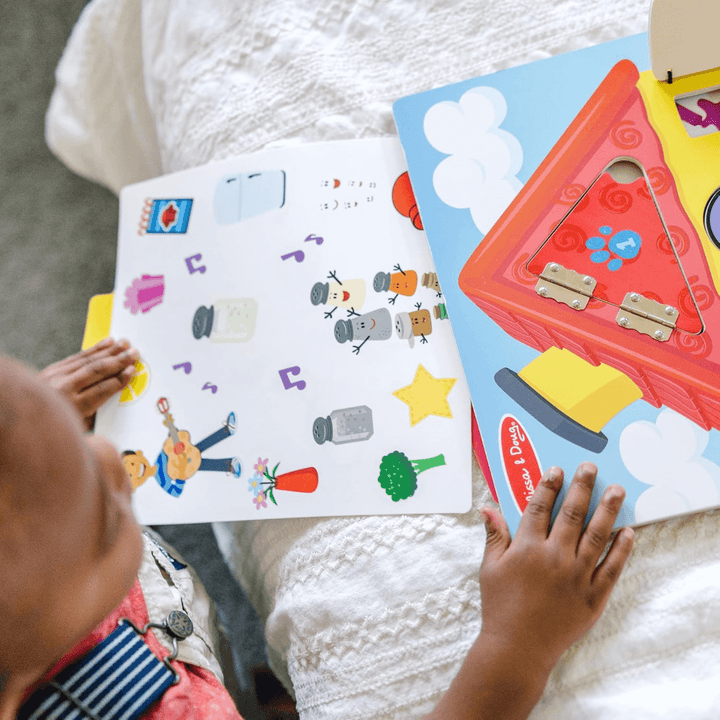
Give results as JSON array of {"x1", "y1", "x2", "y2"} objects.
[{"x1": 423, "y1": 87, "x2": 522, "y2": 234}]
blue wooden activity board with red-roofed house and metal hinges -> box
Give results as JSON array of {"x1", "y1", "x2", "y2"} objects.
[{"x1": 394, "y1": 0, "x2": 720, "y2": 531}]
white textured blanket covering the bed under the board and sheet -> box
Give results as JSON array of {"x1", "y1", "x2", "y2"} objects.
[{"x1": 47, "y1": 0, "x2": 720, "y2": 720}]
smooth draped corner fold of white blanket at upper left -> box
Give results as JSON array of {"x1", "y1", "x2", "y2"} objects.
[{"x1": 45, "y1": 0, "x2": 162, "y2": 192}]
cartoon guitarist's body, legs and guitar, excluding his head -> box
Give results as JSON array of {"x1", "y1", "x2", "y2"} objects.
[{"x1": 155, "y1": 398, "x2": 242, "y2": 497}]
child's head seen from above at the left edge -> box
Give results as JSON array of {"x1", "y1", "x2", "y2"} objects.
[{"x1": 0, "y1": 356, "x2": 142, "y2": 704}]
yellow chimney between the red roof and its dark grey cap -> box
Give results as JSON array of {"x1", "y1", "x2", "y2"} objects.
[{"x1": 518, "y1": 347, "x2": 642, "y2": 432}]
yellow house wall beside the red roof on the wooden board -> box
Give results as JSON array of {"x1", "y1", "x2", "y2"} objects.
[{"x1": 637, "y1": 69, "x2": 720, "y2": 292}]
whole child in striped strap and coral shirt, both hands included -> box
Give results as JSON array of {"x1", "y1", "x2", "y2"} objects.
[{"x1": 0, "y1": 340, "x2": 633, "y2": 720}]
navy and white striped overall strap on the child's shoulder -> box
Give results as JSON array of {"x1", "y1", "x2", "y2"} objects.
[{"x1": 17, "y1": 622, "x2": 177, "y2": 720}]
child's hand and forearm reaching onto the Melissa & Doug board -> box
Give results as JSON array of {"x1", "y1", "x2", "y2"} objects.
[{"x1": 428, "y1": 463, "x2": 634, "y2": 720}]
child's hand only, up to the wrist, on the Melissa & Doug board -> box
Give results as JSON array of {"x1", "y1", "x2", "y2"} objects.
[{"x1": 480, "y1": 463, "x2": 634, "y2": 673}]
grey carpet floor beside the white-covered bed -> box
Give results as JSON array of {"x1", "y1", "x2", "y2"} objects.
[{"x1": 0, "y1": 0, "x2": 265, "y2": 720}]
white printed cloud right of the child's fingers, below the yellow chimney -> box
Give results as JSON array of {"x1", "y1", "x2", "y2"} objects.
[{"x1": 620, "y1": 408, "x2": 720, "y2": 523}]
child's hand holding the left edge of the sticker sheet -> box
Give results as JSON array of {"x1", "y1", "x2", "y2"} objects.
[{"x1": 40, "y1": 338, "x2": 138, "y2": 430}]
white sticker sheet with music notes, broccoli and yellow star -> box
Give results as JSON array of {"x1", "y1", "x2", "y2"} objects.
[{"x1": 90, "y1": 139, "x2": 471, "y2": 524}]
